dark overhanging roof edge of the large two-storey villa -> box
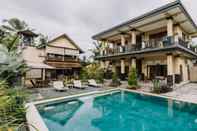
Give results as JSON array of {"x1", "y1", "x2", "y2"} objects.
[{"x1": 92, "y1": 0, "x2": 197, "y2": 40}]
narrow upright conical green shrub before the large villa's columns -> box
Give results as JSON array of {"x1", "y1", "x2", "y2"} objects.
[{"x1": 128, "y1": 67, "x2": 138, "y2": 86}]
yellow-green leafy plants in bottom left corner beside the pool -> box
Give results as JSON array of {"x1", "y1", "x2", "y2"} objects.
[{"x1": 0, "y1": 80, "x2": 26, "y2": 129}]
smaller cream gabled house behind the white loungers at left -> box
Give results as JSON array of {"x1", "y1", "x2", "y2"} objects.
[{"x1": 19, "y1": 31, "x2": 83, "y2": 87}]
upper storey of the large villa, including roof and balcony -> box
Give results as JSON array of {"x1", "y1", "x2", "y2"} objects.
[{"x1": 93, "y1": 1, "x2": 197, "y2": 58}]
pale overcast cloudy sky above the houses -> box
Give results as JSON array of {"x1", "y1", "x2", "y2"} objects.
[{"x1": 0, "y1": 0, "x2": 197, "y2": 54}]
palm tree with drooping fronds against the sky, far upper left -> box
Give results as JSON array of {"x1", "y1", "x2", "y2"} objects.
[{"x1": 1, "y1": 18, "x2": 29, "y2": 50}]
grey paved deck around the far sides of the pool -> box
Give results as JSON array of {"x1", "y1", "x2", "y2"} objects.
[{"x1": 27, "y1": 82, "x2": 197, "y2": 103}]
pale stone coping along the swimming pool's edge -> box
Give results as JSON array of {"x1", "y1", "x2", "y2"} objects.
[{"x1": 26, "y1": 88, "x2": 197, "y2": 131}]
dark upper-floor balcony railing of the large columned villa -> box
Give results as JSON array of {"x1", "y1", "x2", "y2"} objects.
[{"x1": 99, "y1": 37, "x2": 197, "y2": 56}]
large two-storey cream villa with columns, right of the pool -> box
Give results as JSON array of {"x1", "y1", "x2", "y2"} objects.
[{"x1": 92, "y1": 1, "x2": 197, "y2": 85}]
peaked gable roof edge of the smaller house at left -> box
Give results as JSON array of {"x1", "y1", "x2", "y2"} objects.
[{"x1": 48, "y1": 33, "x2": 84, "y2": 53}]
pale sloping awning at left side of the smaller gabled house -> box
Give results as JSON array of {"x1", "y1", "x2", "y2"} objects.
[{"x1": 26, "y1": 62, "x2": 55, "y2": 69}]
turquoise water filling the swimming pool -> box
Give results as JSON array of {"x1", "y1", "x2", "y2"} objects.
[{"x1": 38, "y1": 91, "x2": 197, "y2": 131}]
